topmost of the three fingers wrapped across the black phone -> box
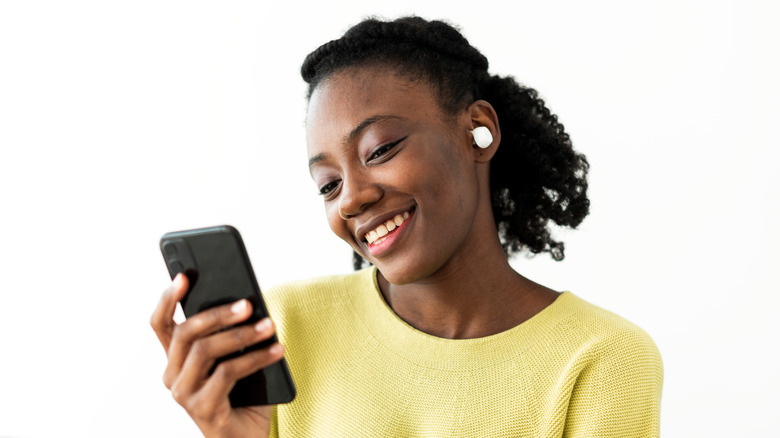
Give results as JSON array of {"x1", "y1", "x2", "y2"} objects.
[{"x1": 163, "y1": 300, "x2": 252, "y2": 388}]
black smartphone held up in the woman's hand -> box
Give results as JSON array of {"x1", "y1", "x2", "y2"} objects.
[{"x1": 160, "y1": 225, "x2": 295, "y2": 407}]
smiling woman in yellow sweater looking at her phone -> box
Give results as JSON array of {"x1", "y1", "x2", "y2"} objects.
[{"x1": 152, "y1": 17, "x2": 662, "y2": 437}]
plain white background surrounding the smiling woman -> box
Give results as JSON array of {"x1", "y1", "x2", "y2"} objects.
[{"x1": 0, "y1": 0, "x2": 780, "y2": 437}]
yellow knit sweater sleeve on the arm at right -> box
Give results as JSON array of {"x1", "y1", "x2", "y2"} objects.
[{"x1": 563, "y1": 327, "x2": 663, "y2": 438}]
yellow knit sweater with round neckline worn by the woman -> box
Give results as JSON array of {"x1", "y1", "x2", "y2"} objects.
[{"x1": 265, "y1": 268, "x2": 663, "y2": 438}]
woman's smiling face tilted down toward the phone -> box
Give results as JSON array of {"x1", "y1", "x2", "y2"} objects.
[{"x1": 307, "y1": 67, "x2": 489, "y2": 284}]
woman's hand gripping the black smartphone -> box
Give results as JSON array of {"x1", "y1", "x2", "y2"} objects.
[{"x1": 151, "y1": 274, "x2": 283, "y2": 437}]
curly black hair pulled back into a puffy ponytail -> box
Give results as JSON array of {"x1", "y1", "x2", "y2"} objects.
[{"x1": 301, "y1": 16, "x2": 590, "y2": 270}]
